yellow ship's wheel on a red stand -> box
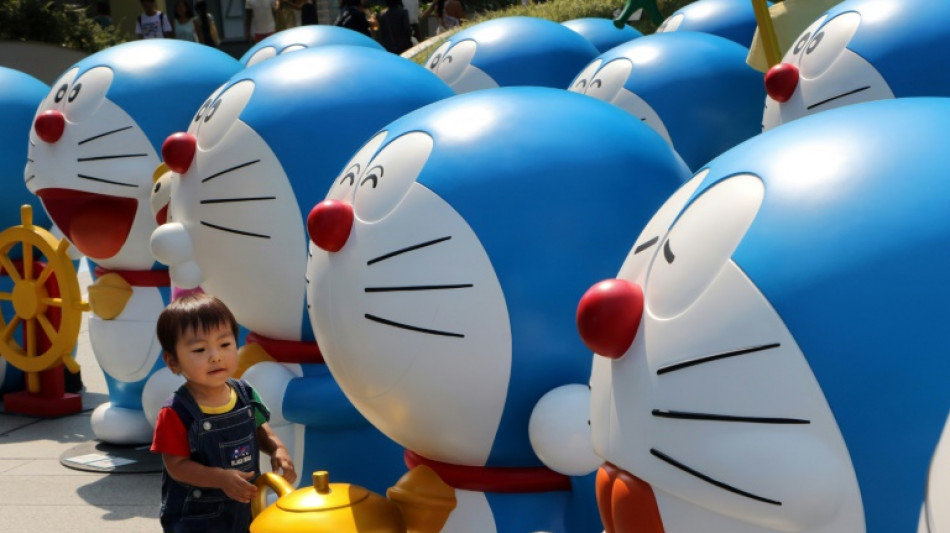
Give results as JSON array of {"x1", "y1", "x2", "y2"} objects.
[{"x1": 0, "y1": 205, "x2": 89, "y2": 393}]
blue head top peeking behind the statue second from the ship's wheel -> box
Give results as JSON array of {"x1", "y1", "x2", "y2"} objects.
[{"x1": 241, "y1": 24, "x2": 383, "y2": 67}]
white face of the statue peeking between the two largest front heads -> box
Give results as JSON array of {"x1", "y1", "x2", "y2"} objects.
[{"x1": 569, "y1": 58, "x2": 673, "y2": 144}]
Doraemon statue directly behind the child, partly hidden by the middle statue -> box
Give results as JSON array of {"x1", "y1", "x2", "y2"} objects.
[{"x1": 152, "y1": 46, "x2": 453, "y2": 491}]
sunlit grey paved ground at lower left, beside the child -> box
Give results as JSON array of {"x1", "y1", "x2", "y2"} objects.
[{"x1": 0, "y1": 272, "x2": 161, "y2": 533}]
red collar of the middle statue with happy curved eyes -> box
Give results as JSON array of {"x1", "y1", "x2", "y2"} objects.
[{"x1": 403, "y1": 450, "x2": 571, "y2": 494}]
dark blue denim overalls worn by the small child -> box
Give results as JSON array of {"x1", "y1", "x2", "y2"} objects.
[{"x1": 161, "y1": 379, "x2": 270, "y2": 533}]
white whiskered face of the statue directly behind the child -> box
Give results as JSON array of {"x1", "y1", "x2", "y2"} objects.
[{"x1": 157, "y1": 80, "x2": 305, "y2": 338}]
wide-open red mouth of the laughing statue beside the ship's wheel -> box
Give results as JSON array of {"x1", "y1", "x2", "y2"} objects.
[{"x1": 36, "y1": 189, "x2": 138, "y2": 259}]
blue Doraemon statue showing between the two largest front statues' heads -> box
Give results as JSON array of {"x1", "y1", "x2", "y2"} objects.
[{"x1": 570, "y1": 32, "x2": 765, "y2": 169}]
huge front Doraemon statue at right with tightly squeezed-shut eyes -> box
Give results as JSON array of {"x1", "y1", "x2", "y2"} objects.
[{"x1": 578, "y1": 98, "x2": 950, "y2": 533}]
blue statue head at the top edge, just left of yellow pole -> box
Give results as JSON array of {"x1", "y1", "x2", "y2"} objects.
[{"x1": 656, "y1": 0, "x2": 755, "y2": 47}]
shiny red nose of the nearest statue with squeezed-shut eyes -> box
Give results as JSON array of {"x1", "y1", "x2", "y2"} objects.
[{"x1": 577, "y1": 279, "x2": 643, "y2": 359}]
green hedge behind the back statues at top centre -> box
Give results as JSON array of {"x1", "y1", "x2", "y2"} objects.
[{"x1": 411, "y1": 0, "x2": 695, "y2": 64}]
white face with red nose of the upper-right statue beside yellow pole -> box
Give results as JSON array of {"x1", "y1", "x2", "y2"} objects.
[{"x1": 762, "y1": 11, "x2": 894, "y2": 130}]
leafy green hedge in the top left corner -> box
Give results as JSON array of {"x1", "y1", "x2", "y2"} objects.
[{"x1": 0, "y1": 0, "x2": 125, "y2": 52}]
